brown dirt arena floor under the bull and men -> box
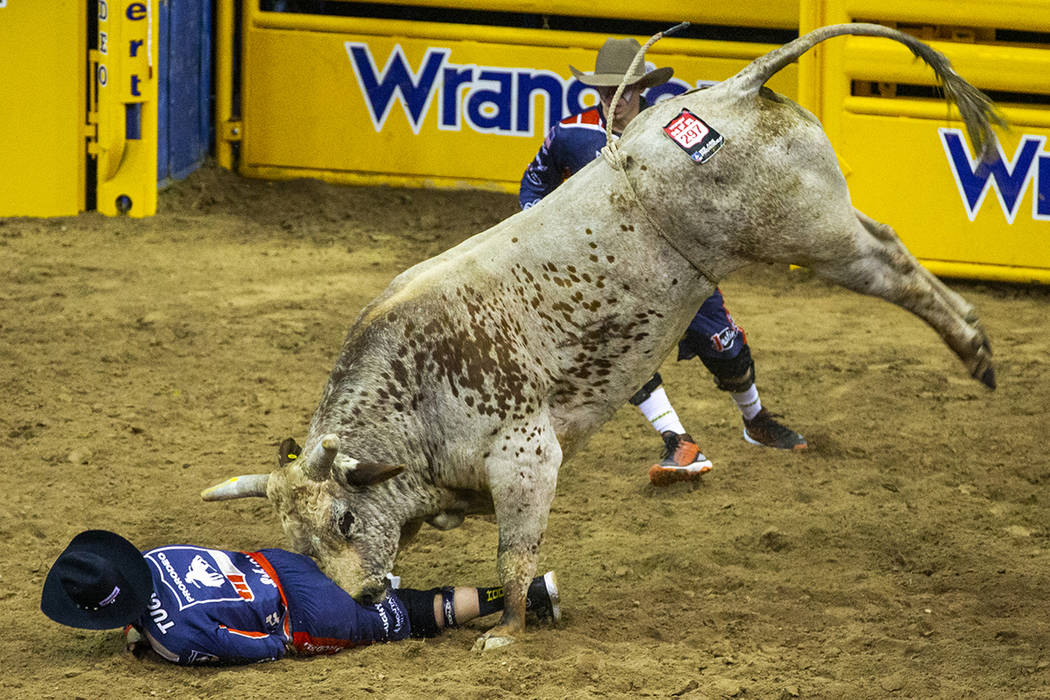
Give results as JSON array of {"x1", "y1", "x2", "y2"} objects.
[{"x1": 0, "y1": 162, "x2": 1050, "y2": 699}]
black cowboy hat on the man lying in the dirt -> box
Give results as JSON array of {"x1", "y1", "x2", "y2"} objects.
[{"x1": 40, "y1": 530, "x2": 153, "y2": 630}]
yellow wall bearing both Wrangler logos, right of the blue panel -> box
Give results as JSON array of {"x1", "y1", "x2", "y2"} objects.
[{"x1": 218, "y1": 0, "x2": 1050, "y2": 282}]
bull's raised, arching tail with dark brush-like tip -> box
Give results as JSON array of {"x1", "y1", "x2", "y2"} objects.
[{"x1": 725, "y1": 22, "x2": 1007, "y2": 156}]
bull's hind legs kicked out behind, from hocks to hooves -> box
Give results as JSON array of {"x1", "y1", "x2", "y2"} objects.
[{"x1": 813, "y1": 210, "x2": 995, "y2": 388}]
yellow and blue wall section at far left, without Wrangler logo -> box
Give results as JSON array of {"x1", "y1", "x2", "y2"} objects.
[{"x1": 0, "y1": 0, "x2": 213, "y2": 216}]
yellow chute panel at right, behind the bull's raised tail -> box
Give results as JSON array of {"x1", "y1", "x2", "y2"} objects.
[{"x1": 799, "y1": 0, "x2": 1050, "y2": 282}]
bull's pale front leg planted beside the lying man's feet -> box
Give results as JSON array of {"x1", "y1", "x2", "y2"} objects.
[{"x1": 475, "y1": 423, "x2": 562, "y2": 650}]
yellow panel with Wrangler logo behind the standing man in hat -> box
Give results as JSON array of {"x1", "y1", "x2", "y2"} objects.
[{"x1": 236, "y1": 3, "x2": 797, "y2": 191}]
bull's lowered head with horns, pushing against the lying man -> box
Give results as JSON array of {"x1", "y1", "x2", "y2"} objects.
[{"x1": 201, "y1": 433, "x2": 404, "y2": 599}]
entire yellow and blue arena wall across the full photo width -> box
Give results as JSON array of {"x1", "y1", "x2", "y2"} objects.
[{"x1": 0, "y1": 0, "x2": 1050, "y2": 283}]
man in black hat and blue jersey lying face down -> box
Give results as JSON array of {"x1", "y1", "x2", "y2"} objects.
[{"x1": 40, "y1": 530, "x2": 561, "y2": 664}]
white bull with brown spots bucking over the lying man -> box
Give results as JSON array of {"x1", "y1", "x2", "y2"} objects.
[{"x1": 203, "y1": 24, "x2": 996, "y2": 646}]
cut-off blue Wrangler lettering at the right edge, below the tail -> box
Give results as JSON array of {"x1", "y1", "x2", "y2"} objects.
[{"x1": 938, "y1": 127, "x2": 1050, "y2": 224}]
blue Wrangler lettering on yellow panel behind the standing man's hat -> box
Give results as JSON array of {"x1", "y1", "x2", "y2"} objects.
[{"x1": 344, "y1": 41, "x2": 690, "y2": 136}]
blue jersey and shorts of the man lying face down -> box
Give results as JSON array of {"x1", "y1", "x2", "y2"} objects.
[{"x1": 134, "y1": 545, "x2": 411, "y2": 664}]
